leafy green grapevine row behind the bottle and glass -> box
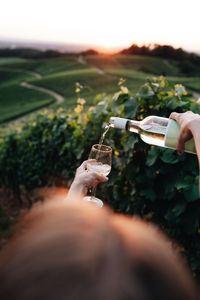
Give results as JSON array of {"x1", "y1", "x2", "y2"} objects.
[{"x1": 0, "y1": 76, "x2": 200, "y2": 278}]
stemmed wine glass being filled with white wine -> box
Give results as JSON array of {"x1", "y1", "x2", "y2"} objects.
[{"x1": 84, "y1": 144, "x2": 112, "y2": 207}]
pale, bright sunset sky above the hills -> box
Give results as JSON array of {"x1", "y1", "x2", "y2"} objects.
[{"x1": 0, "y1": 0, "x2": 200, "y2": 52}]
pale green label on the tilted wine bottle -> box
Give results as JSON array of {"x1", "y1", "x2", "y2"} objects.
[{"x1": 165, "y1": 120, "x2": 196, "y2": 154}]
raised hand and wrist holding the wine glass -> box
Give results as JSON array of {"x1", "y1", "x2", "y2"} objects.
[{"x1": 66, "y1": 159, "x2": 108, "y2": 200}]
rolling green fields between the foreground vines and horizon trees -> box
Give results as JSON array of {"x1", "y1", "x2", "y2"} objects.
[{"x1": 0, "y1": 55, "x2": 200, "y2": 123}]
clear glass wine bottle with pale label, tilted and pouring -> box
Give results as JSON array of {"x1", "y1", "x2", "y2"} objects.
[{"x1": 109, "y1": 116, "x2": 196, "y2": 154}]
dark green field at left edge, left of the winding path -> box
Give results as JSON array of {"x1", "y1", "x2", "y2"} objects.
[{"x1": 0, "y1": 58, "x2": 55, "y2": 123}]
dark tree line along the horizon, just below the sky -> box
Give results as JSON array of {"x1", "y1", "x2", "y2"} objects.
[{"x1": 0, "y1": 44, "x2": 200, "y2": 76}]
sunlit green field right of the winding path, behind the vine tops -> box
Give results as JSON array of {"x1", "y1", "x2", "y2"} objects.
[{"x1": 30, "y1": 68, "x2": 146, "y2": 110}]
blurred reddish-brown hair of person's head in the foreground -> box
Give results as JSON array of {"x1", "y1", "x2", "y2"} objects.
[{"x1": 0, "y1": 201, "x2": 197, "y2": 300}]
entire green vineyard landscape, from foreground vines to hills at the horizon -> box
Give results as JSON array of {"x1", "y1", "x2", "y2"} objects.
[{"x1": 0, "y1": 45, "x2": 200, "y2": 282}]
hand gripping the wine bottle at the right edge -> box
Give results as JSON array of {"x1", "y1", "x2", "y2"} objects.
[{"x1": 169, "y1": 111, "x2": 200, "y2": 155}]
